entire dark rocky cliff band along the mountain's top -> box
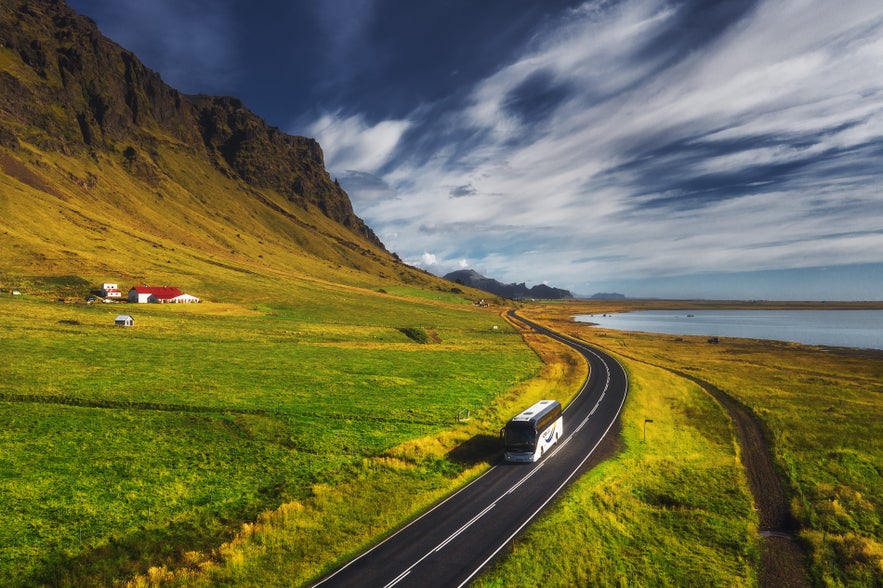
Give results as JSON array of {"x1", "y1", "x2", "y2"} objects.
[{"x1": 0, "y1": 0, "x2": 383, "y2": 248}]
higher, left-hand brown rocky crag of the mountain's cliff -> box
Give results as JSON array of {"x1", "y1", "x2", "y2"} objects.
[{"x1": 0, "y1": 0, "x2": 198, "y2": 152}]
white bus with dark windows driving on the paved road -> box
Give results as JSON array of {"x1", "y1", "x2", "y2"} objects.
[{"x1": 500, "y1": 400, "x2": 564, "y2": 462}]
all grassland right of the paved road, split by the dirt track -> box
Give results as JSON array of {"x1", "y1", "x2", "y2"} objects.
[{"x1": 477, "y1": 302, "x2": 883, "y2": 586}]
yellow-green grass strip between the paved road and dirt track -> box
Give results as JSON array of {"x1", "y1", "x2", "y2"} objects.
[{"x1": 475, "y1": 346, "x2": 758, "y2": 587}]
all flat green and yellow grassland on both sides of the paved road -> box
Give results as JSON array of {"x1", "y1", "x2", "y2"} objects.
[{"x1": 0, "y1": 296, "x2": 883, "y2": 586}]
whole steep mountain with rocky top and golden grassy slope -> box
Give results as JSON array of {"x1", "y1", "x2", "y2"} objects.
[{"x1": 0, "y1": 0, "x2": 452, "y2": 295}]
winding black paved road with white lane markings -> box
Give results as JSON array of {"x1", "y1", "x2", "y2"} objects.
[{"x1": 316, "y1": 313, "x2": 628, "y2": 588}]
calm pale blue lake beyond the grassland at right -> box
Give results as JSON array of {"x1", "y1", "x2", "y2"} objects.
[{"x1": 574, "y1": 310, "x2": 883, "y2": 349}]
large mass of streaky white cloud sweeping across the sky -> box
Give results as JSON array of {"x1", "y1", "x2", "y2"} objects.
[{"x1": 322, "y1": 0, "x2": 883, "y2": 292}]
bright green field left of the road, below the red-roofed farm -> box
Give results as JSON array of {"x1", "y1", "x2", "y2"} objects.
[{"x1": 0, "y1": 290, "x2": 540, "y2": 586}]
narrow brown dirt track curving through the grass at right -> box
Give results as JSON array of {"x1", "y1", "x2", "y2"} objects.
[{"x1": 675, "y1": 372, "x2": 810, "y2": 588}]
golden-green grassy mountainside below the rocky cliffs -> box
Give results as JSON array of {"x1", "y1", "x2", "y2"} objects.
[{"x1": 0, "y1": 138, "x2": 422, "y2": 300}]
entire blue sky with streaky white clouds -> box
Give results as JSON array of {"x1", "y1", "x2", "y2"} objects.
[{"x1": 68, "y1": 0, "x2": 883, "y2": 300}]
